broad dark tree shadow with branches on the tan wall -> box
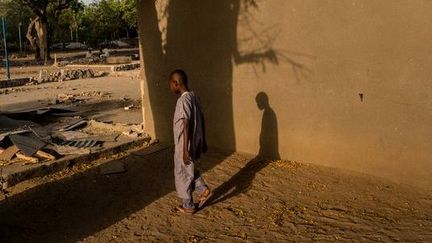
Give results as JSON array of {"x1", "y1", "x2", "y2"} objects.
[{"x1": 138, "y1": 0, "x2": 310, "y2": 151}]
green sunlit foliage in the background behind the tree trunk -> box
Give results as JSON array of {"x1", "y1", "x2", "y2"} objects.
[{"x1": 0, "y1": 0, "x2": 137, "y2": 50}]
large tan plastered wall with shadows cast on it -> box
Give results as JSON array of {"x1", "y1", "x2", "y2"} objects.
[{"x1": 138, "y1": 0, "x2": 432, "y2": 187}]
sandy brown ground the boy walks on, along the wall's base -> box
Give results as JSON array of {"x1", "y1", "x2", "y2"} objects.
[{"x1": 0, "y1": 149, "x2": 432, "y2": 242}]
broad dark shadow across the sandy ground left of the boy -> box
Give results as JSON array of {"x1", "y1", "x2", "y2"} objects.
[{"x1": 0, "y1": 148, "x2": 230, "y2": 242}]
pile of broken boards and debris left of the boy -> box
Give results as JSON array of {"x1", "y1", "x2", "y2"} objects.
[{"x1": 0, "y1": 108, "x2": 146, "y2": 166}]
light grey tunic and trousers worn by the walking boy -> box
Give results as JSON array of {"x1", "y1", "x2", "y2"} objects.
[{"x1": 173, "y1": 92, "x2": 205, "y2": 199}]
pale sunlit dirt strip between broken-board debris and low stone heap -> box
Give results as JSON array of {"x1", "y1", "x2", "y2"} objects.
[{"x1": 0, "y1": 76, "x2": 142, "y2": 124}]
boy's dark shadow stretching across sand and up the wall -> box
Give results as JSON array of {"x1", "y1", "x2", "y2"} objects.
[{"x1": 211, "y1": 92, "x2": 280, "y2": 204}]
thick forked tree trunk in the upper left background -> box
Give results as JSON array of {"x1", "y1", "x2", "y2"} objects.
[{"x1": 21, "y1": 0, "x2": 78, "y2": 64}]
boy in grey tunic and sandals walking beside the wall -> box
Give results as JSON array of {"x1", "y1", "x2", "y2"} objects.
[{"x1": 169, "y1": 69, "x2": 213, "y2": 214}]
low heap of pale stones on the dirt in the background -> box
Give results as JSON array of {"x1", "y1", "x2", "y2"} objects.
[{"x1": 26, "y1": 69, "x2": 105, "y2": 85}]
